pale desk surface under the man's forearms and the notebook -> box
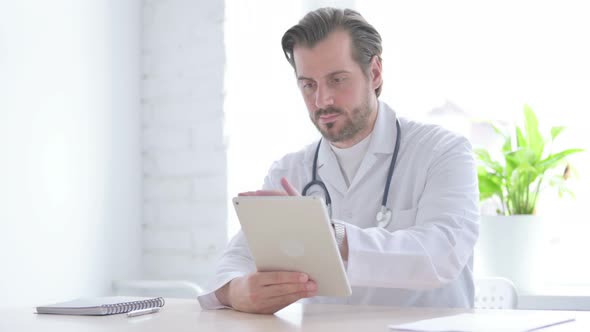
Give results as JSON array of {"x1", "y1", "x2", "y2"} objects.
[{"x1": 0, "y1": 299, "x2": 590, "y2": 332}]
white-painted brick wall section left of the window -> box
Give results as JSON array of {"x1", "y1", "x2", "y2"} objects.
[{"x1": 141, "y1": 0, "x2": 227, "y2": 284}]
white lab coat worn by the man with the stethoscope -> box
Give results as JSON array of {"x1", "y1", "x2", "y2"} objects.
[{"x1": 199, "y1": 102, "x2": 479, "y2": 308}]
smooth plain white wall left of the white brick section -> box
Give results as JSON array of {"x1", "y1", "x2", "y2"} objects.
[{"x1": 0, "y1": 0, "x2": 141, "y2": 306}]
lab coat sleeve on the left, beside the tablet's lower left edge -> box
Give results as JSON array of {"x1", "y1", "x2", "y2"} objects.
[{"x1": 197, "y1": 231, "x2": 256, "y2": 309}]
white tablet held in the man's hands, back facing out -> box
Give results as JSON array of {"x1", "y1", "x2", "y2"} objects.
[{"x1": 233, "y1": 196, "x2": 352, "y2": 296}]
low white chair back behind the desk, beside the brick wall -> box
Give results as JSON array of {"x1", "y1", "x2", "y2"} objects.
[{"x1": 112, "y1": 280, "x2": 202, "y2": 299}]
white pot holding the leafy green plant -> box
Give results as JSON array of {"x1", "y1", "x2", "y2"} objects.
[{"x1": 474, "y1": 215, "x2": 551, "y2": 294}]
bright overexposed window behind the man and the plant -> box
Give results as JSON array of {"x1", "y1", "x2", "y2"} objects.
[{"x1": 225, "y1": 0, "x2": 590, "y2": 290}]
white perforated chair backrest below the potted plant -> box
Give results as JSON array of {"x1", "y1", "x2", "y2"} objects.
[{"x1": 475, "y1": 277, "x2": 518, "y2": 309}]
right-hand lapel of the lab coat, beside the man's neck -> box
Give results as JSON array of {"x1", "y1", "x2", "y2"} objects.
[{"x1": 349, "y1": 102, "x2": 397, "y2": 190}]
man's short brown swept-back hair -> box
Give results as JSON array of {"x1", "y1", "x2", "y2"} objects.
[{"x1": 281, "y1": 7, "x2": 382, "y2": 97}]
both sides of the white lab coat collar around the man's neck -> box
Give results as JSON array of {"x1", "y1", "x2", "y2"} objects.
[{"x1": 312, "y1": 101, "x2": 397, "y2": 193}]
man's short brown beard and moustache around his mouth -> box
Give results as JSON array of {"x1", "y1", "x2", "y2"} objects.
[{"x1": 310, "y1": 102, "x2": 371, "y2": 143}]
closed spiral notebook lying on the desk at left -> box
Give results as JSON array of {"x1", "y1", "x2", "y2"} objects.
[{"x1": 36, "y1": 296, "x2": 164, "y2": 316}]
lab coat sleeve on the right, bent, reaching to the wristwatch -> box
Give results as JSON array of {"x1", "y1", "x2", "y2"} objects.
[{"x1": 345, "y1": 138, "x2": 479, "y2": 289}]
